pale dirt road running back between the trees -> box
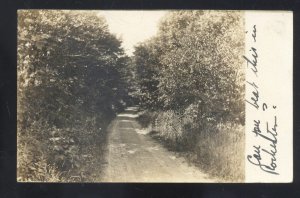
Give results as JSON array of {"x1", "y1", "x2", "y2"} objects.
[{"x1": 102, "y1": 108, "x2": 213, "y2": 182}]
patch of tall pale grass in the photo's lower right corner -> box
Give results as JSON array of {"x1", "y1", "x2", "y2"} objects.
[{"x1": 194, "y1": 123, "x2": 245, "y2": 182}]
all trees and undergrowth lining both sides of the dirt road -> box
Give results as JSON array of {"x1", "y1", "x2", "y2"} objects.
[{"x1": 17, "y1": 10, "x2": 245, "y2": 181}]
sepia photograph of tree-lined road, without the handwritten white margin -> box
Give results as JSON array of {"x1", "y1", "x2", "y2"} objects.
[{"x1": 17, "y1": 10, "x2": 246, "y2": 183}]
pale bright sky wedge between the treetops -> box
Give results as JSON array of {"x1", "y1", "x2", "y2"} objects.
[{"x1": 99, "y1": 11, "x2": 166, "y2": 55}]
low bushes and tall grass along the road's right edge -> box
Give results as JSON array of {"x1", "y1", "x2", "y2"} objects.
[{"x1": 137, "y1": 111, "x2": 245, "y2": 182}]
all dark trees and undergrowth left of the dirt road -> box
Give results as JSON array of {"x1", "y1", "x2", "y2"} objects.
[{"x1": 18, "y1": 10, "x2": 130, "y2": 181}]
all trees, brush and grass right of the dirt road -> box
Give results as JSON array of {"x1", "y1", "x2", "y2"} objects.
[{"x1": 134, "y1": 10, "x2": 245, "y2": 179}]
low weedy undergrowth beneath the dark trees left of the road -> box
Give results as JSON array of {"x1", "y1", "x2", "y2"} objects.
[{"x1": 17, "y1": 113, "x2": 111, "y2": 182}]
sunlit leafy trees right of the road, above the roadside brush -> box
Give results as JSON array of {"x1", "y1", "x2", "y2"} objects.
[{"x1": 135, "y1": 11, "x2": 245, "y2": 123}]
